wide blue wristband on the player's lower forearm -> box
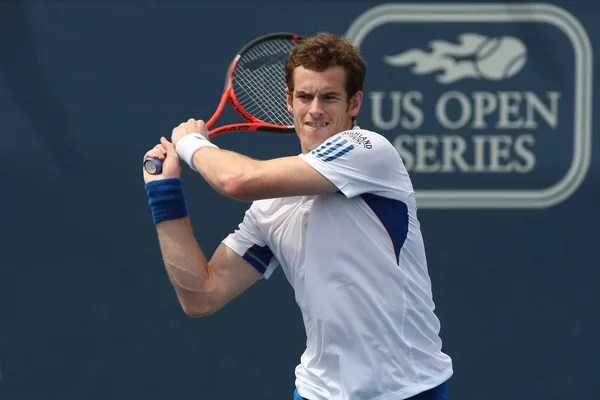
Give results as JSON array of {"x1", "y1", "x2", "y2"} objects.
[{"x1": 145, "y1": 178, "x2": 188, "y2": 224}]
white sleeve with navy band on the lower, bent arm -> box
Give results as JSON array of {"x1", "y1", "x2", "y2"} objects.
[{"x1": 222, "y1": 204, "x2": 279, "y2": 279}]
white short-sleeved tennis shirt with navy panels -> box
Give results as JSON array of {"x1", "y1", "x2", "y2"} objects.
[{"x1": 223, "y1": 127, "x2": 452, "y2": 400}]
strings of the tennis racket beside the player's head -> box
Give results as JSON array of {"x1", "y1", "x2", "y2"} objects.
[{"x1": 232, "y1": 38, "x2": 297, "y2": 126}]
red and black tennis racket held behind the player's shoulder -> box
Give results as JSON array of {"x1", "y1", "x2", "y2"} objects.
[{"x1": 144, "y1": 33, "x2": 302, "y2": 175}]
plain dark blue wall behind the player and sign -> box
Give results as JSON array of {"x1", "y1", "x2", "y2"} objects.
[{"x1": 0, "y1": 0, "x2": 600, "y2": 400}]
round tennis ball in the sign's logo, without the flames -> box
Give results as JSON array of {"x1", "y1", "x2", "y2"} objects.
[{"x1": 475, "y1": 36, "x2": 527, "y2": 80}]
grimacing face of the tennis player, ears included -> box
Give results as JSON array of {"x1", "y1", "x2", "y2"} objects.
[{"x1": 286, "y1": 67, "x2": 362, "y2": 153}]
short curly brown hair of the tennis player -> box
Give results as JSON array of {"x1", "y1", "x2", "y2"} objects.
[{"x1": 285, "y1": 32, "x2": 367, "y2": 101}]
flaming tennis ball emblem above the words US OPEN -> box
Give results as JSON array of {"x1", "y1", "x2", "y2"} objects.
[{"x1": 384, "y1": 33, "x2": 527, "y2": 84}]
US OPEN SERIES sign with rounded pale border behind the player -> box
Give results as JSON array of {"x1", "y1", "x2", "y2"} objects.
[{"x1": 346, "y1": 3, "x2": 592, "y2": 208}]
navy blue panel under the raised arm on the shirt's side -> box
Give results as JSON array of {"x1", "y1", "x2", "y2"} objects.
[{"x1": 361, "y1": 193, "x2": 408, "y2": 264}]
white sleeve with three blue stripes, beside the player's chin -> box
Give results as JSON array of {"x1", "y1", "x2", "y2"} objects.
[{"x1": 299, "y1": 129, "x2": 413, "y2": 200}]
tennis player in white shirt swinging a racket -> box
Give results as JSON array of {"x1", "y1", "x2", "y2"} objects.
[{"x1": 144, "y1": 33, "x2": 453, "y2": 400}]
